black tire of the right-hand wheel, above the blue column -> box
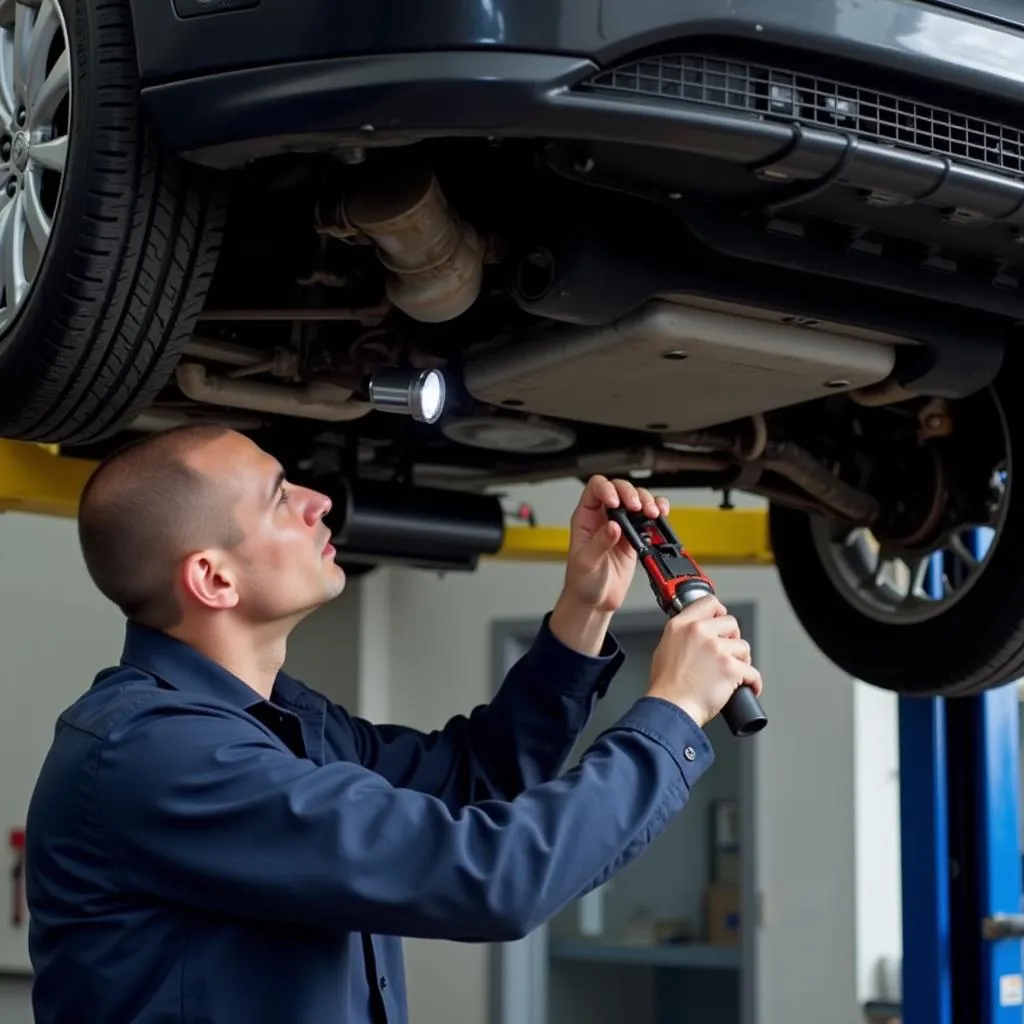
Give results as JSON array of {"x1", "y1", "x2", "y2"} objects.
[{"x1": 769, "y1": 370, "x2": 1024, "y2": 696}]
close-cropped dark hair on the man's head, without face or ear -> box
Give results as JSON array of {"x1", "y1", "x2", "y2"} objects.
[{"x1": 78, "y1": 426, "x2": 243, "y2": 629}]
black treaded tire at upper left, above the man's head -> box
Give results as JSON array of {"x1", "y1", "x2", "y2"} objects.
[{"x1": 0, "y1": 0, "x2": 224, "y2": 443}]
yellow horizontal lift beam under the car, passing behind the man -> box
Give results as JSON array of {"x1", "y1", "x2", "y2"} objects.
[{"x1": 0, "y1": 440, "x2": 772, "y2": 565}]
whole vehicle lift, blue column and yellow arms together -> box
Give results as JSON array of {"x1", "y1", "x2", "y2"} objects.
[{"x1": 0, "y1": 439, "x2": 1024, "y2": 1024}]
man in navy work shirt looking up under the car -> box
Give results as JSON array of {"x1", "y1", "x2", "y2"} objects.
[{"x1": 27, "y1": 427, "x2": 762, "y2": 1024}]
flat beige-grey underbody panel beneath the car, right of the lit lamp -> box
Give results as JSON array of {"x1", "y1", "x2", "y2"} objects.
[{"x1": 465, "y1": 301, "x2": 895, "y2": 433}]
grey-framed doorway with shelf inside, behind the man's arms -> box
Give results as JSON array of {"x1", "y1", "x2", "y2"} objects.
[{"x1": 490, "y1": 603, "x2": 757, "y2": 1024}]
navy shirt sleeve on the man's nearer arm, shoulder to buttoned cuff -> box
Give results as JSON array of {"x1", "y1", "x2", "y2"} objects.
[{"x1": 94, "y1": 696, "x2": 714, "y2": 941}]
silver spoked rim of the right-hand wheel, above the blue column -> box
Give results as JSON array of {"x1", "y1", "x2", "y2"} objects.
[{"x1": 811, "y1": 402, "x2": 1012, "y2": 626}]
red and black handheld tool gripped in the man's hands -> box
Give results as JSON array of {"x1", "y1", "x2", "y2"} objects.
[{"x1": 608, "y1": 508, "x2": 768, "y2": 736}]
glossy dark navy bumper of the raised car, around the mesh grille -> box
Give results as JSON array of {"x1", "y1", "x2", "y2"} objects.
[{"x1": 132, "y1": 0, "x2": 1024, "y2": 165}]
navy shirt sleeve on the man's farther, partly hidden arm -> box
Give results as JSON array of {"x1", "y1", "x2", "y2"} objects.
[{"x1": 333, "y1": 613, "x2": 625, "y2": 811}]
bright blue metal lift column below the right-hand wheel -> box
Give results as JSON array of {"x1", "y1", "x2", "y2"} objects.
[{"x1": 899, "y1": 531, "x2": 1024, "y2": 1024}]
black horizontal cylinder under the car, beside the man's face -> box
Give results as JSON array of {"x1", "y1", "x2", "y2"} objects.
[{"x1": 321, "y1": 480, "x2": 505, "y2": 569}]
